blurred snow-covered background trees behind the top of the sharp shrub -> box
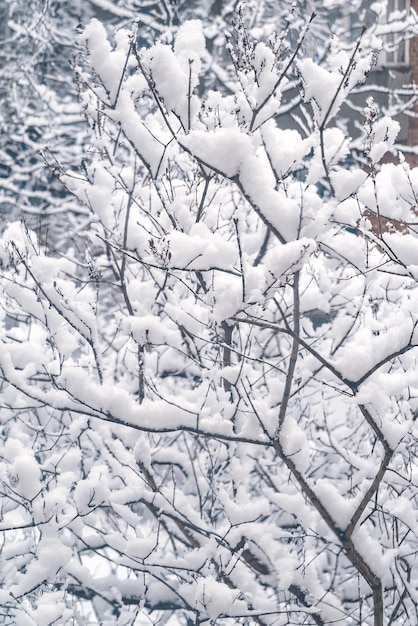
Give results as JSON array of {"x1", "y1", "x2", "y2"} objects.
[{"x1": 0, "y1": 0, "x2": 416, "y2": 246}]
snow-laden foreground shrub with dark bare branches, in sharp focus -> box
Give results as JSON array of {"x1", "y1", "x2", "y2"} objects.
[{"x1": 0, "y1": 0, "x2": 418, "y2": 626}]
